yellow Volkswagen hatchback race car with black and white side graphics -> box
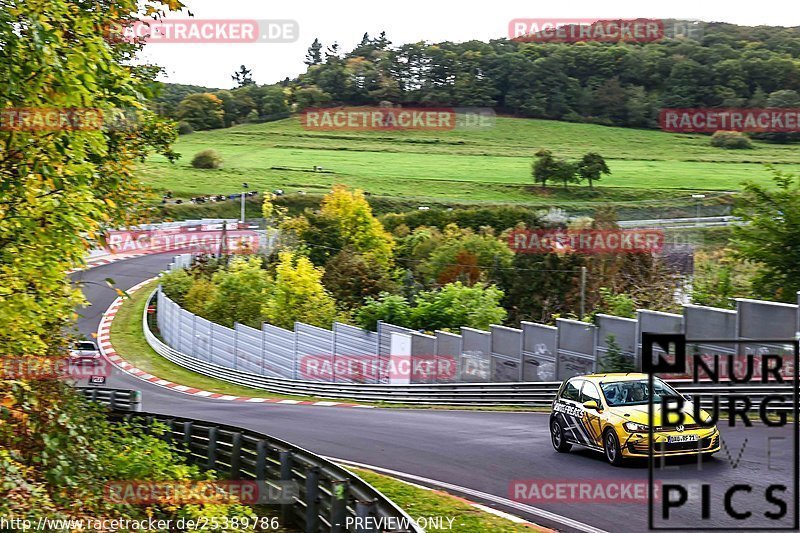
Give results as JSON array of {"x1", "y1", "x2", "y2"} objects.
[{"x1": 550, "y1": 373, "x2": 720, "y2": 465}]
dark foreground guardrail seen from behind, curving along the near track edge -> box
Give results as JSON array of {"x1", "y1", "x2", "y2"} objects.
[{"x1": 78, "y1": 387, "x2": 424, "y2": 533}]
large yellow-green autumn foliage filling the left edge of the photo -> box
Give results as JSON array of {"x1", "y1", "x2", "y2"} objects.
[{"x1": 0, "y1": 0, "x2": 252, "y2": 529}]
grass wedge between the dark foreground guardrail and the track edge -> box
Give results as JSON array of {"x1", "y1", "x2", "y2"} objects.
[{"x1": 347, "y1": 467, "x2": 549, "y2": 533}]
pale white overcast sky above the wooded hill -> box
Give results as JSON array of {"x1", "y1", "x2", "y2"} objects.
[{"x1": 142, "y1": 0, "x2": 800, "y2": 88}]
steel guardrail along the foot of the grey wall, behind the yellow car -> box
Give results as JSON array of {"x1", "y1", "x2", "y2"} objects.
[{"x1": 142, "y1": 293, "x2": 792, "y2": 409}]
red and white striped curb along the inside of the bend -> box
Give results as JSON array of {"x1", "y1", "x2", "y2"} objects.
[{"x1": 97, "y1": 276, "x2": 373, "y2": 409}]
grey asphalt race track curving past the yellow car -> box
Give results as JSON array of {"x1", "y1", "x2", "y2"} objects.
[{"x1": 72, "y1": 254, "x2": 797, "y2": 533}]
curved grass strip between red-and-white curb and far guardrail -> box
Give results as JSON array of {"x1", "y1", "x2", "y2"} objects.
[{"x1": 111, "y1": 280, "x2": 549, "y2": 411}]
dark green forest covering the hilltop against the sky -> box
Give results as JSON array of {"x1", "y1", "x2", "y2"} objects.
[{"x1": 157, "y1": 21, "x2": 800, "y2": 141}]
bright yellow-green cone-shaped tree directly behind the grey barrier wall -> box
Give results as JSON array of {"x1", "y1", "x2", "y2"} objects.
[{"x1": 262, "y1": 252, "x2": 336, "y2": 329}]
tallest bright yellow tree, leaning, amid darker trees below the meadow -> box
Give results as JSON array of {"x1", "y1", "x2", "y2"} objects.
[{"x1": 320, "y1": 185, "x2": 395, "y2": 268}]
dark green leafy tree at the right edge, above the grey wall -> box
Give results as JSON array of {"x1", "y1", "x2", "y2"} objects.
[{"x1": 731, "y1": 169, "x2": 800, "y2": 303}]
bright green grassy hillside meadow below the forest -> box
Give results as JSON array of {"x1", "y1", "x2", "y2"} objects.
[{"x1": 142, "y1": 117, "x2": 800, "y2": 204}]
